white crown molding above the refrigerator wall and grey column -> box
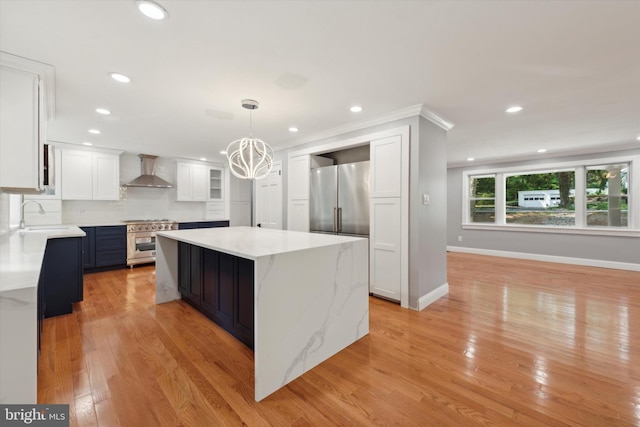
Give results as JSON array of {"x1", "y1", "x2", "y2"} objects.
[{"x1": 277, "y1": 104, "x2": 454, "y2": 154}]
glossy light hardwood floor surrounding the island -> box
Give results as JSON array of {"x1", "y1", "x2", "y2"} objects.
[{"x1": 38, "y1": 253, "x2": 640, "y2": 427}]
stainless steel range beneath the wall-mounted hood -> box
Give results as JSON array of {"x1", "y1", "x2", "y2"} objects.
[{"x1": 123, "y1": 219, "x2": 178, "y2": 268}]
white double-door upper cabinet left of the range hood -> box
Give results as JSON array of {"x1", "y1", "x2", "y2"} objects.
[{"x1": 61, "y1": 149, "x2": 120, "y2": 200}]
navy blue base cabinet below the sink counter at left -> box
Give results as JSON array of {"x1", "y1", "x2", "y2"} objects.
[{"x1": 38, "y1": 237, "x2": 84, "y2": 317}]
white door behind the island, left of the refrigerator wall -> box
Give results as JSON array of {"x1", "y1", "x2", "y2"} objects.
[{"x1": 255, "y1": 162, "x2": 282, "y2": 230}]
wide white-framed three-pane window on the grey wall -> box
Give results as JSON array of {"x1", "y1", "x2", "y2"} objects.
[{"x1": 463, "y1": 156, "x2": 640, "y2": 236}]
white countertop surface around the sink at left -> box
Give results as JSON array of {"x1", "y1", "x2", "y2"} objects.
[{"x1": 0, "y1": 225, "x2": 85, "y2": 292}]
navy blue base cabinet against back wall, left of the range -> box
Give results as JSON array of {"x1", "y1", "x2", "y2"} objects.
[{"x1": 81, "y1": 225, "x2": 127, "y2": 269}]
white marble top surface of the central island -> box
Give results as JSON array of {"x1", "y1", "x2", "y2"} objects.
[{"x1": 157, "y1": 227, "x2": 366, "y2": 260}]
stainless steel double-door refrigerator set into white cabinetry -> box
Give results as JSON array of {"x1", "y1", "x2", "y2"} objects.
[{"x1": 309, "y1": 161, "x2": 369, "y2": 236}]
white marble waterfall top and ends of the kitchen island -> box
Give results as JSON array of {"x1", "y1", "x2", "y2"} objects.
[{"x1": 156, "y1": 227, "x2": 369, "y2": 401}]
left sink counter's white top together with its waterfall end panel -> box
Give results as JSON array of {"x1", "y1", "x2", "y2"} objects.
[{"x1": 0, "y1": 226, "x2": 85, "y2": 403}]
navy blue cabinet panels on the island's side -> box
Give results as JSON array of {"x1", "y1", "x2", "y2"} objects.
[{"x1": 178, "y1": 242, "x2": 254, "y2": 348}]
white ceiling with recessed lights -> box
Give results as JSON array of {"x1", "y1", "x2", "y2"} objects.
[{"x1": 0, "y1": 0, "x2": 640, "y2": 165}]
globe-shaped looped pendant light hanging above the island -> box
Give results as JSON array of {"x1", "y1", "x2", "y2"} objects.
[{"x1": 227, "y1": 99, "x2": 273, "y2": 179}]
